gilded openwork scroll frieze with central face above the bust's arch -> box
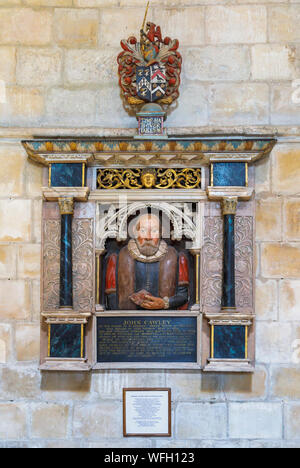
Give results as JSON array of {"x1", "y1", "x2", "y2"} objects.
[{"x1": 97, "y1": 168, "x2": 201, "y2": 190}]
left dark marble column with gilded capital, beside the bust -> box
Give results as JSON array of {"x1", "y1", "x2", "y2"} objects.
[{"x1": 59, "y1": 198, "x2": 74, "y2": 308}]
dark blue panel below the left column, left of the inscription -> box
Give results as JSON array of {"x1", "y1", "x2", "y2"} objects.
[{"x1": 50, "y1": 324, "x2": 81, "y2": 358}]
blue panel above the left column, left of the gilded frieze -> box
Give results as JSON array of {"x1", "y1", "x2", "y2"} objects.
[{"x1": 51, "y1": 163, "x2": 82, "y2": 187}]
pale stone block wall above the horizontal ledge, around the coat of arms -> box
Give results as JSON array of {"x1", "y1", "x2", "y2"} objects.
[{"x1": 0, "y1": 0, "x2": 300, "y2": 127}]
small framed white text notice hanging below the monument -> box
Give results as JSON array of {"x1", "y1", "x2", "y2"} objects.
[{"x1": 123, "y1": 388, "x2": 172, "y2": 437}]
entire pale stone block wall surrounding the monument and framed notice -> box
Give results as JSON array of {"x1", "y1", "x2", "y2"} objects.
[{"x1": 0, "y1": 0, "x2": 300, "y2": 447}]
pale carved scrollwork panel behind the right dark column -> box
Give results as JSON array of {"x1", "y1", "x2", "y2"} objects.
[{"x1": 201, "y1": 216, "x2": 253, "y2": 311}]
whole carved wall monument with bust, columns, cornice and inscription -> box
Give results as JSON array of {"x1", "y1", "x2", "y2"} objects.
[{"x1": 23, "y1": 136, "x2": 275, "y2": 372}]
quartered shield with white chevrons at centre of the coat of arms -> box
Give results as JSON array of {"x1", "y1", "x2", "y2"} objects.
[{"x1": 136, "y1": 63, "x2": 167, "y2": 102}]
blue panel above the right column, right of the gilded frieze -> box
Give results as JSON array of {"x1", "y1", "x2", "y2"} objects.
[{"x1": 213, "y1": 163, "x2": 246, "y2": 187}]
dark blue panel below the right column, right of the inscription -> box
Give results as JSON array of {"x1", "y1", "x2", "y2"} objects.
[{"x1": 214, "y1": 325, "x2": 246, "y2": 359}]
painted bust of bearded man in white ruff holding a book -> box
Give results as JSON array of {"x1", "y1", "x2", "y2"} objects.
[{"x1": 105, "y1": 214, "x2": 189, "y2": 310}]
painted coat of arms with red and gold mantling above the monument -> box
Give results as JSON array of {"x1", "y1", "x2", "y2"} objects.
[{"x1": 118, "y1": 2, "x2": 182, "y2": 109}]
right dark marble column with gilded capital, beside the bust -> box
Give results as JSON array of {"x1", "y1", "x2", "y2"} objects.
[{"x1": 222, "y1": 197, "x2": 237, "y2": 309}]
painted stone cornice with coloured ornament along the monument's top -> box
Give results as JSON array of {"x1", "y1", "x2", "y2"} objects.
[{"x1": 22, "y1": 135, "x2": 276, "y2": 167}]
